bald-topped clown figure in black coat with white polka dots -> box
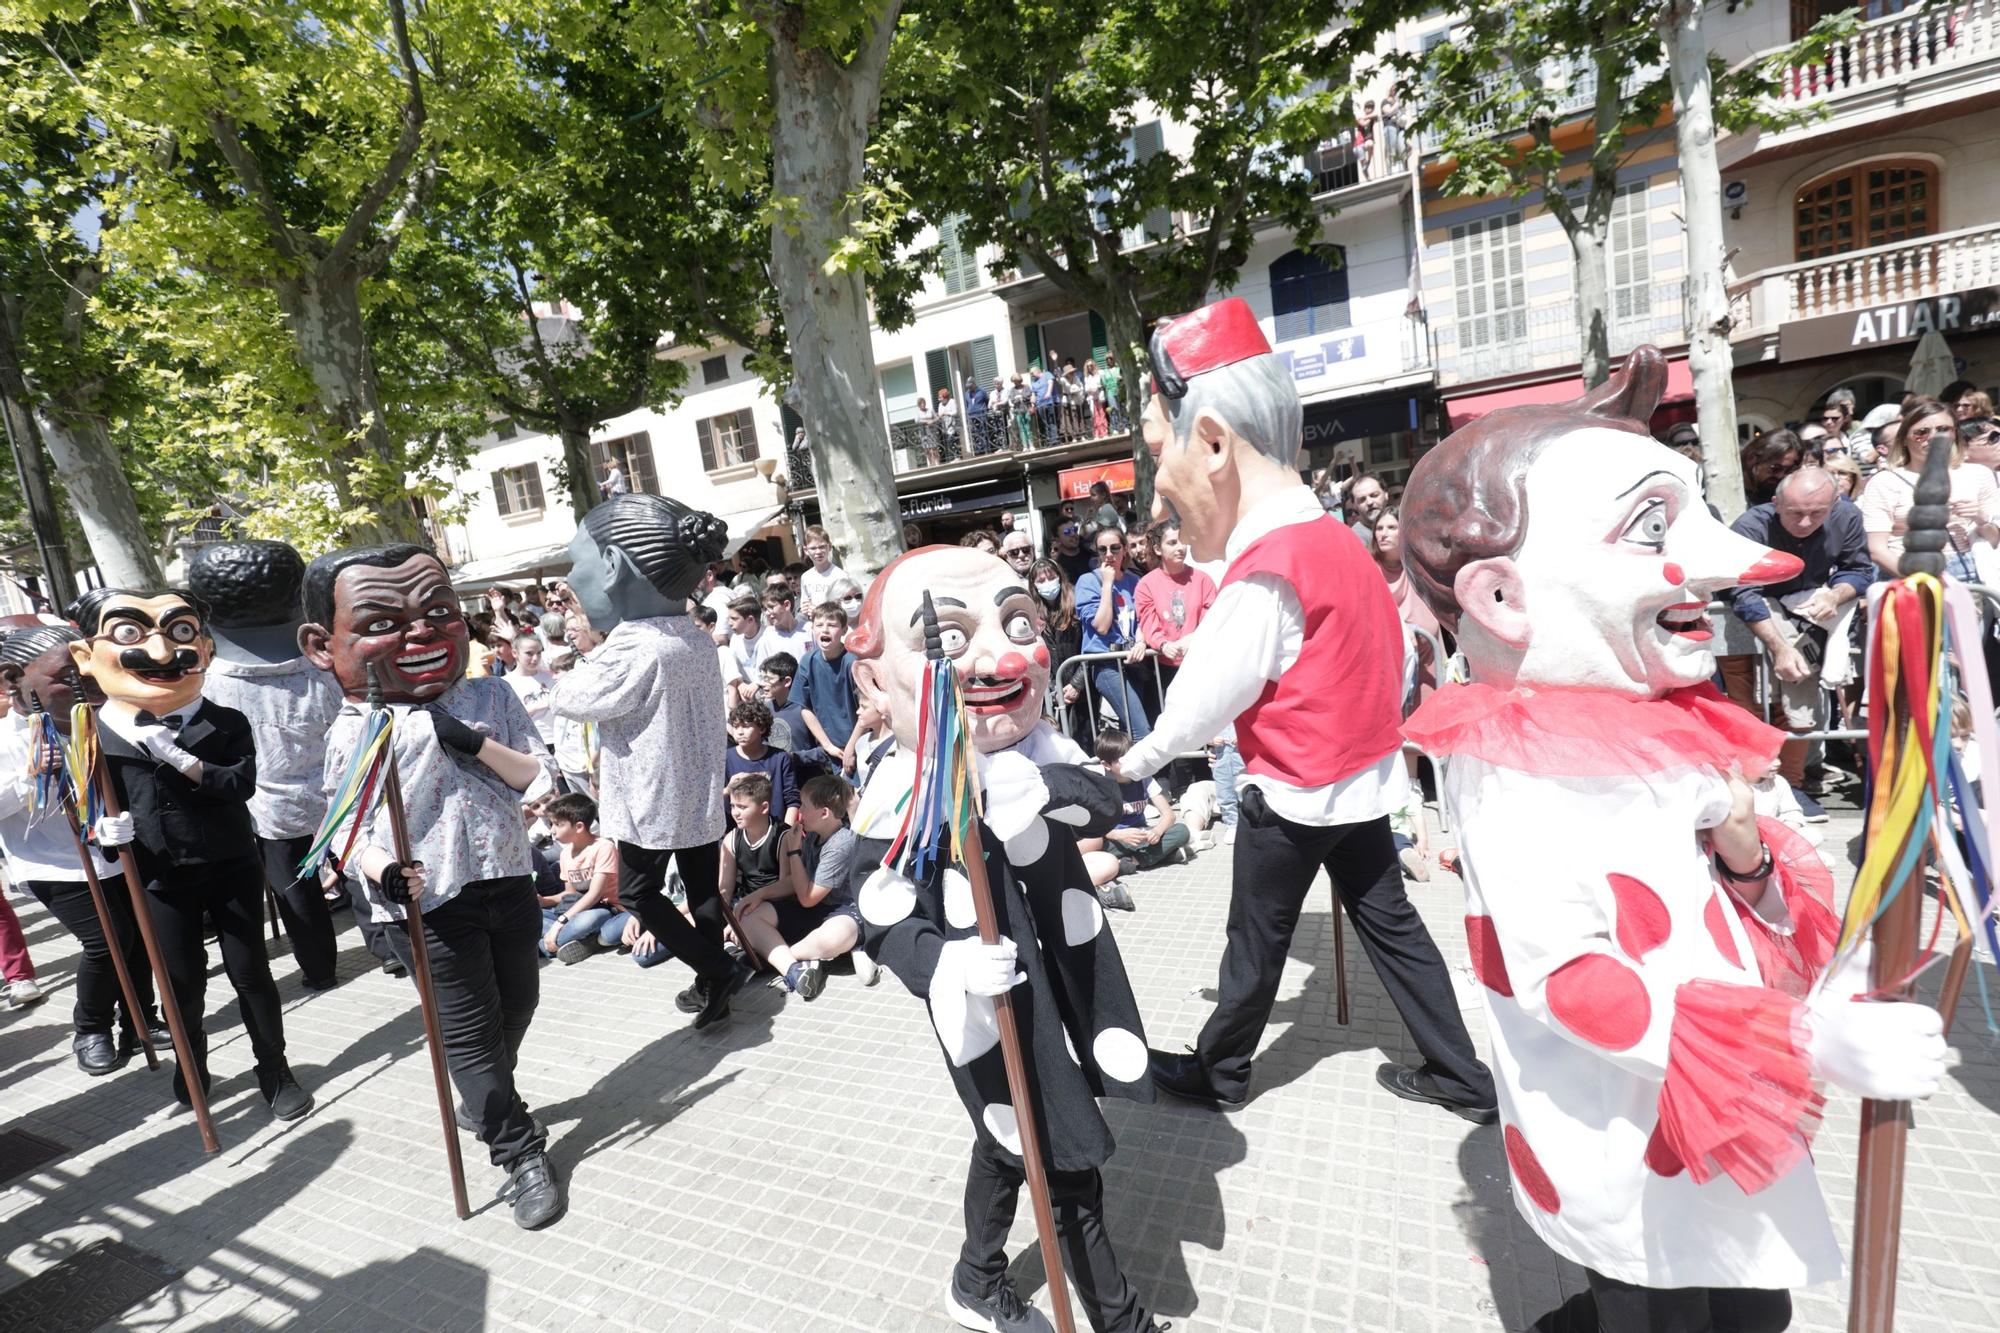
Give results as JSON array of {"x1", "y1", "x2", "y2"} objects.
[{"x1": 846, "y1": 546, "x2": 1156, "y2": 1333}]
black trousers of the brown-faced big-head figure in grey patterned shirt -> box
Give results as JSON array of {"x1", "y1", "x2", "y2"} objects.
[{"x1": 388, "y1": 875, "x2": 548, "y2": 1167}]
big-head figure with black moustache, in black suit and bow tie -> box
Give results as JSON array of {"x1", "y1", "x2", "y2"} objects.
[{"x1": 70, "y1": 588, "x2": 312, "y2": 1119}]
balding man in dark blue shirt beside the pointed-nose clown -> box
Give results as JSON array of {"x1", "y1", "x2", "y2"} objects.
[{"x1": 1716, "y1": 466, "x2": 1876, "y2": 823}]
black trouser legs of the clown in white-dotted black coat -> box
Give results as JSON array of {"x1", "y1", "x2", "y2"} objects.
[{"x1": 958, "y1": 1139, "x2": 1154, "y2": 1333}]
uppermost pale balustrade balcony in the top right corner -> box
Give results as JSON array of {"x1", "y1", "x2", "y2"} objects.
[{"x1": 1722, "y1": 0, "x2": 2000, "y2": 168}]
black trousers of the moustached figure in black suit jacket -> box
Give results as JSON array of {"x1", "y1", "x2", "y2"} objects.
[{"x1": 146, "y1": 857, "x2": 286, "y2": 1091}]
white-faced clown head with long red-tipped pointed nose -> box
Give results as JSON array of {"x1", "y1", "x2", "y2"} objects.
[{"x1": 1402, "y1": 346, "x2": 1802, "y2": 697}]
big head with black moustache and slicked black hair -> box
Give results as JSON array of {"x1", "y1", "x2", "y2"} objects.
[{"x1": 70, "y1": 588, "x2": 214, "y2": 715}]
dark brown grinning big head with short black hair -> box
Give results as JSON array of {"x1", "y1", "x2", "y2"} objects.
[{"x1": 298, "y1": 544, "x2": 470, "y2": 705}]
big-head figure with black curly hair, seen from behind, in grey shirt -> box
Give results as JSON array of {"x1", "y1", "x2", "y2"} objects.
[{"x1": 188, "y1": 542, "x2": 340, "y2": 991}]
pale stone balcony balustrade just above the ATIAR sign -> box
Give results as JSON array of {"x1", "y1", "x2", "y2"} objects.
[{"x1": 1730, "y1": 222, "x2": 2000, "y2": 340}]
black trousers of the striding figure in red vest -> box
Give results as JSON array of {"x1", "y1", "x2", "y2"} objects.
[{"x1": 1196, "y1": 787, "x2": 1494, "y2": 1105}]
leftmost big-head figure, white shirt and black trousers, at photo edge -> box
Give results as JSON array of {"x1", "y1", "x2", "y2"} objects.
[{"x1": 0, "y1": 624, "x2": 168, "y2": 1077}]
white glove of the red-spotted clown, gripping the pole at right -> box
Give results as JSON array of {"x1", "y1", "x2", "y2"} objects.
[{"x1": 1806, "y1": 945, "x2": 1946, "y2": 1101}]
